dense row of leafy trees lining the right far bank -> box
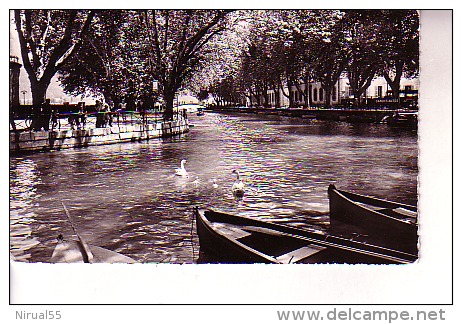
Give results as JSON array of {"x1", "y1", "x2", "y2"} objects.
[{"x1": 206, "y1": 10, "x2": 419, "y2": 106}]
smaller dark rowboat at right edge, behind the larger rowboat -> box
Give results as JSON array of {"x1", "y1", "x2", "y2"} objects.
[{"x1": 328, "y1": 185, "x2": 418, "y2": 252}]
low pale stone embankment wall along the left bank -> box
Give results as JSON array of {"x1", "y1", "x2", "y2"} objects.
[{"x1": 10, "y1": 118, "x2": 189, "y2": 153}]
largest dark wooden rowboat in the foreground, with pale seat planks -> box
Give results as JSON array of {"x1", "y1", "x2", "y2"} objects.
[{"x1": 195, "y1": 209, "x2": 417, "y2": 264}]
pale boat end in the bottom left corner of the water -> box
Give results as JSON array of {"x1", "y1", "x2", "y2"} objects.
[{"x1": 50, "y1": 236, "x2": 136, "y2": 263}]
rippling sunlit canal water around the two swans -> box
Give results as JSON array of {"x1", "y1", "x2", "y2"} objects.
[{"x1": 10, "y1": 113, "x2": 418, "y2": 263}]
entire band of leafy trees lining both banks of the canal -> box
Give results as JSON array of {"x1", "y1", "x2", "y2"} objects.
[{"x1": 14, "y1": 10, "x2": 419, "y2": 123}]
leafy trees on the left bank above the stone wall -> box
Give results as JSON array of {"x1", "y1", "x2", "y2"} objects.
[{"x1": 14, "y1": 10, "x2": 233, "y2": 120}]
